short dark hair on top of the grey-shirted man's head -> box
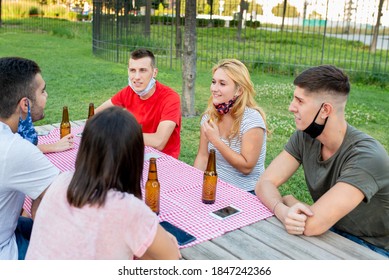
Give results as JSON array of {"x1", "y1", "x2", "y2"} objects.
[{"x1": 293, "y1": 65, "x2": 350, "y2": 96}]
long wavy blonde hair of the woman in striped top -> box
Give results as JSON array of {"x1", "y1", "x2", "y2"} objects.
[{"x1": 204, "y1": 59, "x2": 266, "y2": 139}]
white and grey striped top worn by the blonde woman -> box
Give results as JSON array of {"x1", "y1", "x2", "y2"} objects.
[{"x1": 201, "y1": 107, "x2": 266, "y2": 191}]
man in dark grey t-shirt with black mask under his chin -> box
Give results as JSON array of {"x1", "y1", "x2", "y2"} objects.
[{"x1": 256, "y1": 65, "x2": 389, "y2": 257}]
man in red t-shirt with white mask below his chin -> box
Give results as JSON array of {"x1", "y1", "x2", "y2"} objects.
[{"x1": 96, "y1": 49, "x2": 181, "y2": 158}]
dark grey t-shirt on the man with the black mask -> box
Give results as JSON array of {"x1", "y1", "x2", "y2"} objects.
[{"x1": 285, "y1": 125, "x2": 389, "y2": 250}]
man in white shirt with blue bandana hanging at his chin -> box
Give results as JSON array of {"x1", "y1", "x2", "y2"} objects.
[{"x1": 0, "y1": 57, "x2": 60, "y2": 259}]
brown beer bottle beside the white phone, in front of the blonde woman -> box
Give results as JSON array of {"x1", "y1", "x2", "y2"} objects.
[{"x1": 202, "y1": 149, "x2": 217, "y2": 204}]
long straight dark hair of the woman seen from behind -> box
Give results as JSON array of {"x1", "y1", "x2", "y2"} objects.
[{"x1": 67, "y1": 106, "x2": 144, "y2": 208}]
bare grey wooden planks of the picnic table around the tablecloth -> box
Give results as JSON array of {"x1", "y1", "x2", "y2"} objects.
[{"x1": 36, "y1": 120, "x2": 387, "y2": 260}]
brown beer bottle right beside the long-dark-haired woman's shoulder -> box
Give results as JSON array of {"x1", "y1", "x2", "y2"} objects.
[{"x1": 145, "y1": 158, "x2": 160, "y2": 215}]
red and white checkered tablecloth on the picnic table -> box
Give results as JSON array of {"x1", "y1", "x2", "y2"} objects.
[{"x1": 25, "y1": 124, "x2": 273, "y2": 248}]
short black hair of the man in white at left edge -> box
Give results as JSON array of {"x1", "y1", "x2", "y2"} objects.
[{"x1": 0, "y1": 57, "x2": 41, "y2": 119}]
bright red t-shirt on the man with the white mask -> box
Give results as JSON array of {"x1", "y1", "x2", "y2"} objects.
[{"x1": 111, "y1": 81, "x2": 181, "y2": 158}]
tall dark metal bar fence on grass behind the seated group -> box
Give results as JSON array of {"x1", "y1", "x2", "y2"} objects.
[{"x1": 2, "y1": 0, "x2": 389, "y2": 76}]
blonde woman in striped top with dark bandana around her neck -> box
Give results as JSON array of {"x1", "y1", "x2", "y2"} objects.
[{"x1": 194, "y1": 59, "x2": 267, "y2": 192}]
